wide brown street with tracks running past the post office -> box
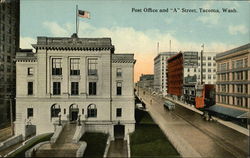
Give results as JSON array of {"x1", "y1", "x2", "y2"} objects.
[{"x1": 136, "y1": 89, "x2": 249, "y2": 158}]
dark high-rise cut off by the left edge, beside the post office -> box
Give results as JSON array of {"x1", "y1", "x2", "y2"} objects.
[{"x1": 0, "y1": 0, "x2": 20, "y2": 126}]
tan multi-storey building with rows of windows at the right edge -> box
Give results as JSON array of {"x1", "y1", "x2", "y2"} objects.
[{"x1": 216, "y1": 43, "x2": 250, "y2": 110}]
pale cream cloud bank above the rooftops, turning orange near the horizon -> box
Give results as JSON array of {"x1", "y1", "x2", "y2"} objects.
[{"x1": 42, "y1": 22, "x2": 234, "y2": 80}]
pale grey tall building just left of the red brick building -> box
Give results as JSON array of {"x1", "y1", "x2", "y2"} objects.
[{"x1": 154, "y1": 52, "x2": 177, "y2": 95}]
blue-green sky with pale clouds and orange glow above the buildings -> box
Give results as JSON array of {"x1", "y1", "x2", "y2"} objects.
[{"x1": 20, "y1": 0, "x2": 250, "y2": 81}]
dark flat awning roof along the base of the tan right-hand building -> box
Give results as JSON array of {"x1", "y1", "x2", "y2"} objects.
[{"x1": 206, "y1": 105, "x2": 249, "y2": 118}]
